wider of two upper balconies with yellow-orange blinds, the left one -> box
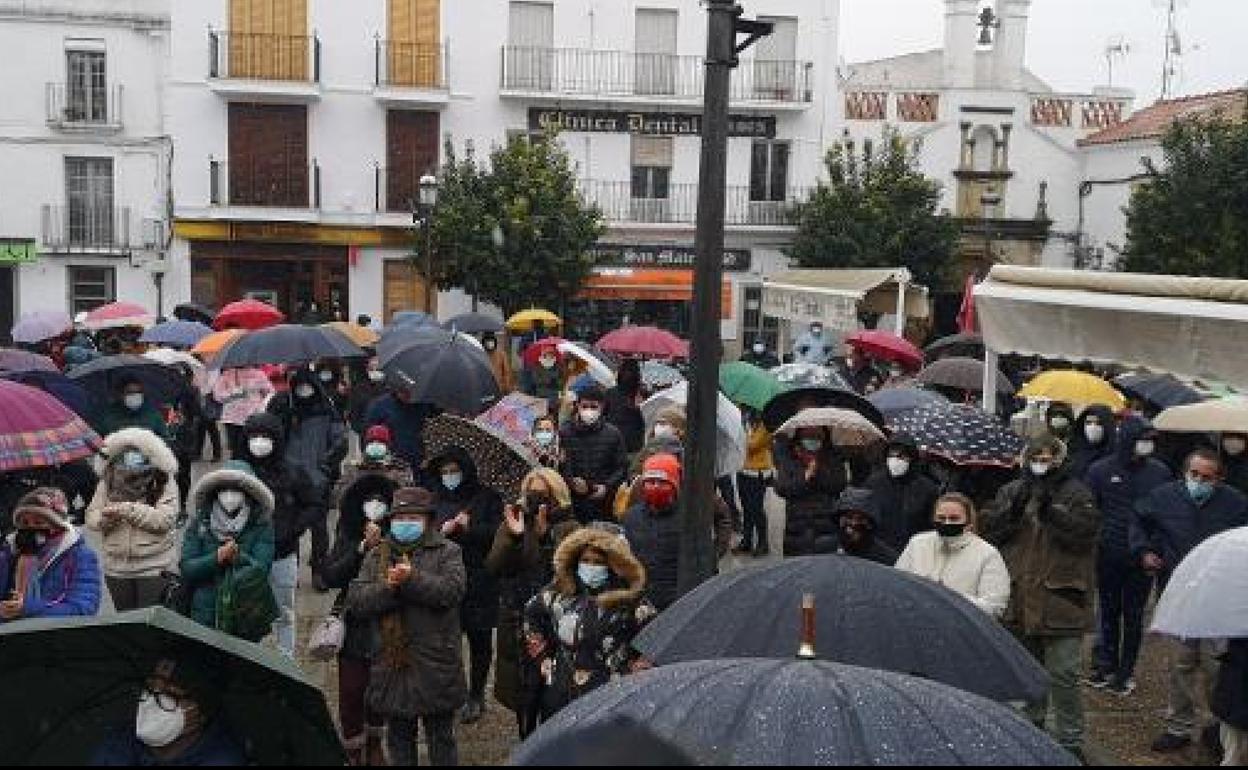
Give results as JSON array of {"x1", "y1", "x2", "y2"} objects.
[{"x1": 208, "y1": 30, "x2": 321, "y2": 104}]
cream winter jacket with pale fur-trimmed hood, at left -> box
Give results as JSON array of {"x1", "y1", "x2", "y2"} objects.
[{"x1": 86, "y1": 428, "x2": 178, "y2": 578}]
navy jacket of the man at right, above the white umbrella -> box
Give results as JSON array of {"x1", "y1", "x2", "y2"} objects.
[{"x1": 1129, "y1": 480, "x2": 1248, "y2": 574}]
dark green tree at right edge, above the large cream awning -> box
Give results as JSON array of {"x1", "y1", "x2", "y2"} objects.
[{"x1": 1118, "y1": 107, "x2": 1248, "y2": 278}]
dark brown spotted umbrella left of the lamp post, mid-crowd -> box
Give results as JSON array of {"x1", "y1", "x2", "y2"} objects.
[{"x1": 422, "y1": 414, "x2": 538, "y2": 500}]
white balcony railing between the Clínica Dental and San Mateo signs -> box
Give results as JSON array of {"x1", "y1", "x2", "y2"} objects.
[{"x1": 578, "y1": 180, "x2": 807, "y2": 227}]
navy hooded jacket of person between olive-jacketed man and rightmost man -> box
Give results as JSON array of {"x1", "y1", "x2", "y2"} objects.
[{"x1": 1085, "y1": 417, "x2": 1174, "y2": 564}]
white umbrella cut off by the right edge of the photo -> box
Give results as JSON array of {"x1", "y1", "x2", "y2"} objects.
[{"x1": 1152, "y1": 527, "x2": 1248, "y2": 639}]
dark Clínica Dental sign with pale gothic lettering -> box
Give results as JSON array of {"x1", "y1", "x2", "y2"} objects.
[{"x1": 529, "y1": 107, "x2": 776, "y2": 139}]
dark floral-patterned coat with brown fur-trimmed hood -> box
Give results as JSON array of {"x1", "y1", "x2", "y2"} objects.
[{"x1": 523, "y1": 528, "x2": 658, "y2": 719}]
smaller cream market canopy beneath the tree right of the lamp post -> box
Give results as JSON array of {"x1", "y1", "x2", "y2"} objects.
[{"x1": 763, "y1": 267, "x2": 931, "y2": 332}]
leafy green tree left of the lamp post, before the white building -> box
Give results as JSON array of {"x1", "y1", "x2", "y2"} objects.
[{"x1": 432, "y1": 134, "x2": 603, "y2": 313}]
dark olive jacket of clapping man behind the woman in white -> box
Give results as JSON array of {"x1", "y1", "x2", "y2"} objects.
[{"x1": 981, "y1": 441, "x2": 1101, "y2": 636}]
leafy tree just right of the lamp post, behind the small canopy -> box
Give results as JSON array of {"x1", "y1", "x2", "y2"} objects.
[{"x1": 787, "y1": 130, "x2": 957, "y2": 287}]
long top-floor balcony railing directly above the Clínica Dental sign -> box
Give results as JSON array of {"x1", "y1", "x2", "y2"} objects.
[{"x1": 502, "y1": 46, "x2": 814, "y2": 110}]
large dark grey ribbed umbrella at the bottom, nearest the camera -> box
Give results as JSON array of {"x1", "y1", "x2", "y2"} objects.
[{"x1": 512, "y1": 658, "x2": 1077, "y2": 766}]
